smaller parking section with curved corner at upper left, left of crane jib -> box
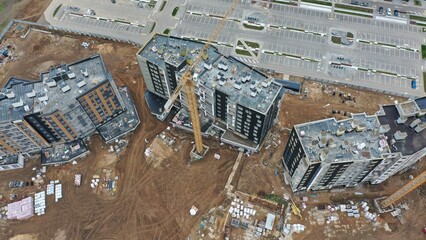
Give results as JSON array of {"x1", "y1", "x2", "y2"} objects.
[{"x1": 44, "y1": 0, "x2": 185, "y2": 44}]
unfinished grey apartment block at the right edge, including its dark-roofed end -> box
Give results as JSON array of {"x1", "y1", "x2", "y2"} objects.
[{"x1": 282, "y1": 98, "x2": 426, "y2": 192}]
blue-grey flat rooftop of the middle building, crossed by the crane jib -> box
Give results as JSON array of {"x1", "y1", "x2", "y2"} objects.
[{"x1": 139, "y1": 34, "x2": 281, "y2": 113}]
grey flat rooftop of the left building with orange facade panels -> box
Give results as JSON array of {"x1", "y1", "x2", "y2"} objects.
[{"x1": 0, "y1": 55, "x2": 112, "y2": 127}]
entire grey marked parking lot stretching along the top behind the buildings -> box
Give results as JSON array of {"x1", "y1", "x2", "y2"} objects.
[{"x1": 44, "y1": 0, "x2": 425, "y2": 95}]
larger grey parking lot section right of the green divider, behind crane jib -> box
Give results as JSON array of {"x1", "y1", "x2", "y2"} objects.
[{"x1": 172, "y1": 0, "x2": 424, "y2": 95}]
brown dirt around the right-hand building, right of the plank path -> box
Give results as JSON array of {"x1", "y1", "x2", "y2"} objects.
[{"x1": 237, "y1": 82, "x2": 426, "y2": 239}]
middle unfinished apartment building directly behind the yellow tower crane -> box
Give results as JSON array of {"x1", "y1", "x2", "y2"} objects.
[{"x1": 137, "y1": 34, "x2": 281, "y2": 151}]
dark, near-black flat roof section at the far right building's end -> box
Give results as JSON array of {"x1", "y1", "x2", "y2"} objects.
[{"x1": 378, "y1": 105, "x2": 426, "y2": 155}]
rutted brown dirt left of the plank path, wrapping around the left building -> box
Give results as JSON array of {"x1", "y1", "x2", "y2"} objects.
[{"x1": 0, "y1": 25, "x2": 237, "y2": 240}]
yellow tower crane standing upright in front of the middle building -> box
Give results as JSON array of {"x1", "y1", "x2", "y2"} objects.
[{"x1": 163, "y1": 0, "x2": 240, "y2": 154}]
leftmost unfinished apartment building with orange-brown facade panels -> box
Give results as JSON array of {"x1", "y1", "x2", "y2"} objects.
[{"x1": 0, "y1": 55, "x2": 139, "y2": 170}]
